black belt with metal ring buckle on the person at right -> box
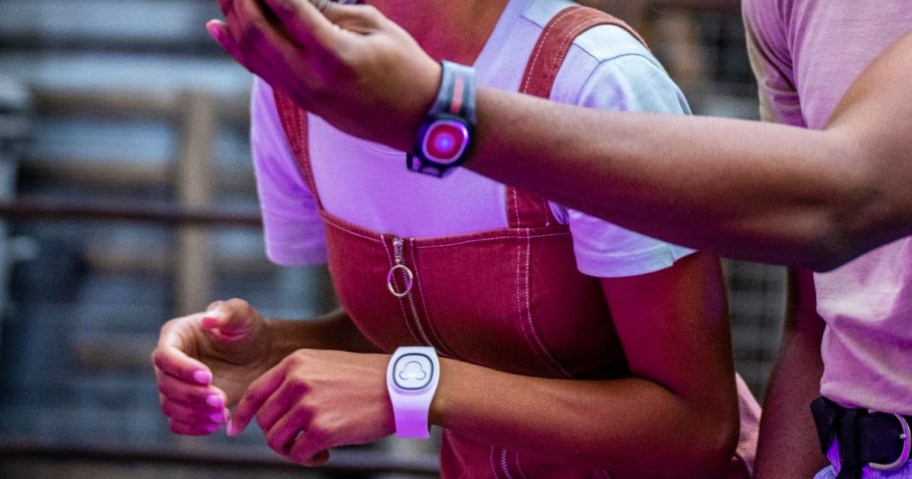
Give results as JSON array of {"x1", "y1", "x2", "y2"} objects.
[{"x1": 811, "y1": 397, "x2": 912, "y2": 479}]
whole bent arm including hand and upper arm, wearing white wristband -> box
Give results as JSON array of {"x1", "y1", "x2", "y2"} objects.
[{"x1": 229, "y1": 253, "x2": 738, "y2": 477}]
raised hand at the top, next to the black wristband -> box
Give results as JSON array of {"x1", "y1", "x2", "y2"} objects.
[{"x1": 207, "y1": 0, "x2": 440, "y2": 150}]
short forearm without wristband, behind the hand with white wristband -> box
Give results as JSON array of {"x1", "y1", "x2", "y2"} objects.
[{"x1": 267, "y1": 309, "x2": 379, "y2": 364}]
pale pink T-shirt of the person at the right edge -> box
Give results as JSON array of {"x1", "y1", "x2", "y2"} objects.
[{"x1": 743, "y1": 0, "x2": 912, "y2": 477}]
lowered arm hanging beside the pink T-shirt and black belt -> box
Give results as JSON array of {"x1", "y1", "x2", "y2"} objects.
[{"x1": 754, "y1": 270, "x2": 826, "y2": 479}]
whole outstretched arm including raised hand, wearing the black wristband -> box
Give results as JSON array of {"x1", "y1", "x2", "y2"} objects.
[{"x1": 209, "y1": 0, "x2": 912, "y2": 270}]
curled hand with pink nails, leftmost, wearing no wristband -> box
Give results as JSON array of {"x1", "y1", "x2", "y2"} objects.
[{"x1": 152, "y1": 299, "x2": 273, "y2": 436}]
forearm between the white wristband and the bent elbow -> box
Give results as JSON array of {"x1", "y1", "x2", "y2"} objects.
[{"x1": 431, "y1": 359, "x2": 738, "y2": 477}]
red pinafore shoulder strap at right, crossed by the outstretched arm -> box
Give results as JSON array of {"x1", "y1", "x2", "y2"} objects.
[{"x1": 506, "y1": 6, "x2": 646, "y2": 228}]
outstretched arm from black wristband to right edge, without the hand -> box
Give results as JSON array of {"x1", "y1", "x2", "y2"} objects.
[{"x1": 468, "y1": 35, "x2": 912, "y2": 270}]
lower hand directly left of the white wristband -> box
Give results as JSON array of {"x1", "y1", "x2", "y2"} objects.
[{"x1": 228, "y1": 349, "x2": 395, "y2": 466}]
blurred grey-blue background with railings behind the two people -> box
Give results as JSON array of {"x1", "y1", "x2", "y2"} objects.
[{"x1": 0, "y1": 0, "x2": 784, "y2": 479}]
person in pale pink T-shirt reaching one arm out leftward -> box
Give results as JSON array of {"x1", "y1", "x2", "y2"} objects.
[{"x1": 182, "y1": 0, "x2": 912, "y2": 479}]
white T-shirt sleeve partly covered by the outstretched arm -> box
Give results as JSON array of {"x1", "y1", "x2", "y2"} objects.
[{"x1": 565, "y1": 31, "x2": 693, "y2": 278}]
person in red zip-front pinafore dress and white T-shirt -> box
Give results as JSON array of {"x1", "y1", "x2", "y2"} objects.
[{"x1": 155, "y1": 0, "x2": 759, "y2": 479}]
